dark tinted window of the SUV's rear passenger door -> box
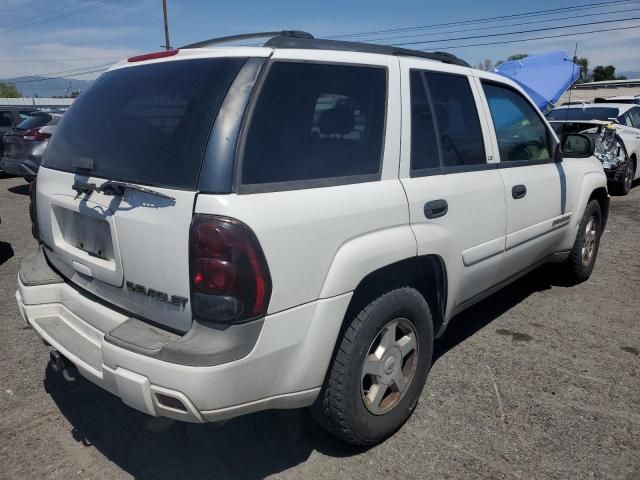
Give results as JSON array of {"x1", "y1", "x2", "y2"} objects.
[{"x1": 411, "y1": 70, "x2": 486, "y2": 171}]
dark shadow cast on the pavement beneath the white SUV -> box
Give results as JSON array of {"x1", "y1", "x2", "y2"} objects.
[{"x1": 44, "y1": 268, "x2": 568, "y2": 480}]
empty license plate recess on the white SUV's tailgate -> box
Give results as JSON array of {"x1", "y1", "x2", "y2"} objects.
[{"x1": 55, "y1": 207, "x2": 114, "y2": 261}]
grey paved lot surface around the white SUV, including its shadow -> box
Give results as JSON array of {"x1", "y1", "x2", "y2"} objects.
[{"x1": 0, "y1": 178, "x2": 640, "y2": 479}]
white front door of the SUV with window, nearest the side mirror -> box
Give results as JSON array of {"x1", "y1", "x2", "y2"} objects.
[{"x1": 478, "y1": 73, "x2": 572, "y2": 280}]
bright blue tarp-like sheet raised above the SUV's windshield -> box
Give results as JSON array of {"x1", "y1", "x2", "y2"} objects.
[{"x1": 494, "y1": 52, "x2": 580, "y2": 112}]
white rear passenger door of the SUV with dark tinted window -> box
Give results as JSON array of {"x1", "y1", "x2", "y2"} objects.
[{"x1": 400, "y1": 59, "x2": 506, "y2": 315}]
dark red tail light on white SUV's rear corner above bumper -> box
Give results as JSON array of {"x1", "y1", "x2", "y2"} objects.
[{"x1": 189, "y1": 214, "x2": 271, "y2": 323}]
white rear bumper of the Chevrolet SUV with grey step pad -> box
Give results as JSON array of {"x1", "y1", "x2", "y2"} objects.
[{"x1": 16, "y1": 248, "x2": 351, "y2": 422}]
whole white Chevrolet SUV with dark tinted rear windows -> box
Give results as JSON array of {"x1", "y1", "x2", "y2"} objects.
[{"x1": 16, "y1": 32, "x2": 609, "y2": 445}]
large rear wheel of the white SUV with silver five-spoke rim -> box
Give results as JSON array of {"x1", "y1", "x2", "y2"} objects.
[{"x1": 311, "y1": 287, "x2": 433, "y2": 446}]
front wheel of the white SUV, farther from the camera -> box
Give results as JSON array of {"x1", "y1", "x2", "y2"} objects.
[{"x1": 565, "y1": 200, "x2": 602, "y2": 284}]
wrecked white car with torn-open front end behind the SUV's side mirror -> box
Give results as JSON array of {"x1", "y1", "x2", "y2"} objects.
[{"x1": 547, "y1": 103, "x2": 640, "y2": 195}]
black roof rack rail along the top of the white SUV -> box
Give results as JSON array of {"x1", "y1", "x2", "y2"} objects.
[{"x1": 181, "y1": 30, "x2": 470, "y2": 67}]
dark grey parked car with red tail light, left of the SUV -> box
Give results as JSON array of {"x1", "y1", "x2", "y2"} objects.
[{"x1": 0, "y1": 112, "x2": 62, "y2": 181}]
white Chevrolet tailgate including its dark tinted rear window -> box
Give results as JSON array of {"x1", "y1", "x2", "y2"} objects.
[{"x1": 37, "y1": 57, "x2": 246, "y2": 331}]
